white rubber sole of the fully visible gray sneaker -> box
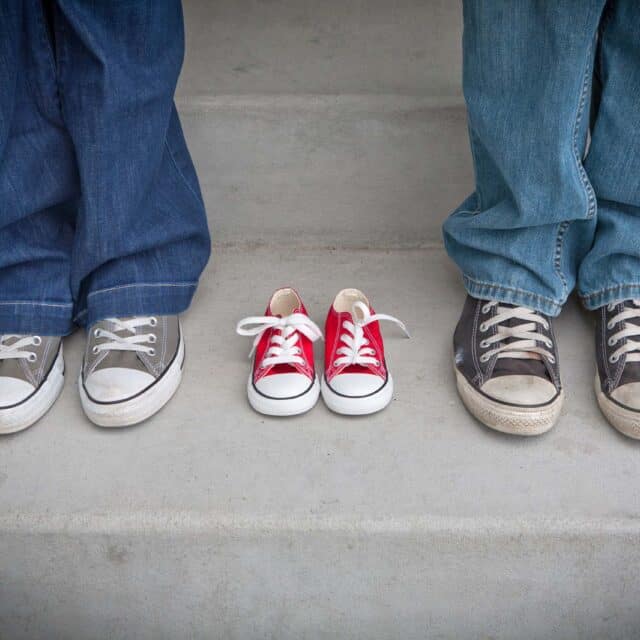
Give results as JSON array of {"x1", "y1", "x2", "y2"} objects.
[{"x1": 78, "y1": 333, "x2": 184, "y2": 427}]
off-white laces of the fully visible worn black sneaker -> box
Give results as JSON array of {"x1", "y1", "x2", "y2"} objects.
[{"x1": 479, "y1": 300, "x2": 556, "y2": 364}]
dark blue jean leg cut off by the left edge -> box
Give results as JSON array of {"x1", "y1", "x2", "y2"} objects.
[{"x1": 0, "y1": 0, "x2": 78, "y2": 335}]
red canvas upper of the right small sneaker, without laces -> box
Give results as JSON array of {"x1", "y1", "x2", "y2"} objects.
[{"x1": 324, "y1": 298, "x2": 387, "y2": 382}]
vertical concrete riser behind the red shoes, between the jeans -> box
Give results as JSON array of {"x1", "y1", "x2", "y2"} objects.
[{"x1": 179, "y1": 95, "x2": 473, "y2": 248}]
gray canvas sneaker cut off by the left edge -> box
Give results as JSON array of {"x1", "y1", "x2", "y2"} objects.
[{"x1": 0, "y1": 335, "x2": 64, "y2": 434}]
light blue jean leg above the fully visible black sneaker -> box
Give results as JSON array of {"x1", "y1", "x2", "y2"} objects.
[{"x1": 444, "y1": 0, "x2": 605, "y2": 315}]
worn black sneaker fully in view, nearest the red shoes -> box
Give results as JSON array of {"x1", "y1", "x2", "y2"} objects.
[{"x1": 454, "y1": 296, "x2": 564, "y2": 436}]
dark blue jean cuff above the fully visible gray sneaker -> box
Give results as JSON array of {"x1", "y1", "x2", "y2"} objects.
[{"x1": 74, "y1": 282, "x2": 198, "y2": 327}]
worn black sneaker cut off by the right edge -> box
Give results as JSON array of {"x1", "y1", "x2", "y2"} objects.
[{"x1": 595, "y1": 300, "x2": 640, "y2": 439}]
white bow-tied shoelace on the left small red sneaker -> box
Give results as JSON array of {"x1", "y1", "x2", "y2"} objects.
[{"x1": 236, "y1": 313, "x2": 322, "y2": 368}]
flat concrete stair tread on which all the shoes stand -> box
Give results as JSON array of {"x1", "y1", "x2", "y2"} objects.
[{"x1": 0, "y1": 247, "x2": 640, "y2": 535}]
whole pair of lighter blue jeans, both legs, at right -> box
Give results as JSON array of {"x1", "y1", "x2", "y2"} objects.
[{"x1": 444, "y1": 0, "x2": 640, "y2": 315}]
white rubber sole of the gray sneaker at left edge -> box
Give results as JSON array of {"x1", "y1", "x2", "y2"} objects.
[{"x1": 0, "y1": 345, "x2": 64, "y2": 434}]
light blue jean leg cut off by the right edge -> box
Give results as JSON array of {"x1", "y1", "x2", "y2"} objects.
[{"x1": 579, "y1": 0, "x2": 640, "y2": 309}]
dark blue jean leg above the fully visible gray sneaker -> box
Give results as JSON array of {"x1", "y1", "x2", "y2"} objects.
[{"x1": 54, "y1": 0, "x2": 210, "y2": 325}]
